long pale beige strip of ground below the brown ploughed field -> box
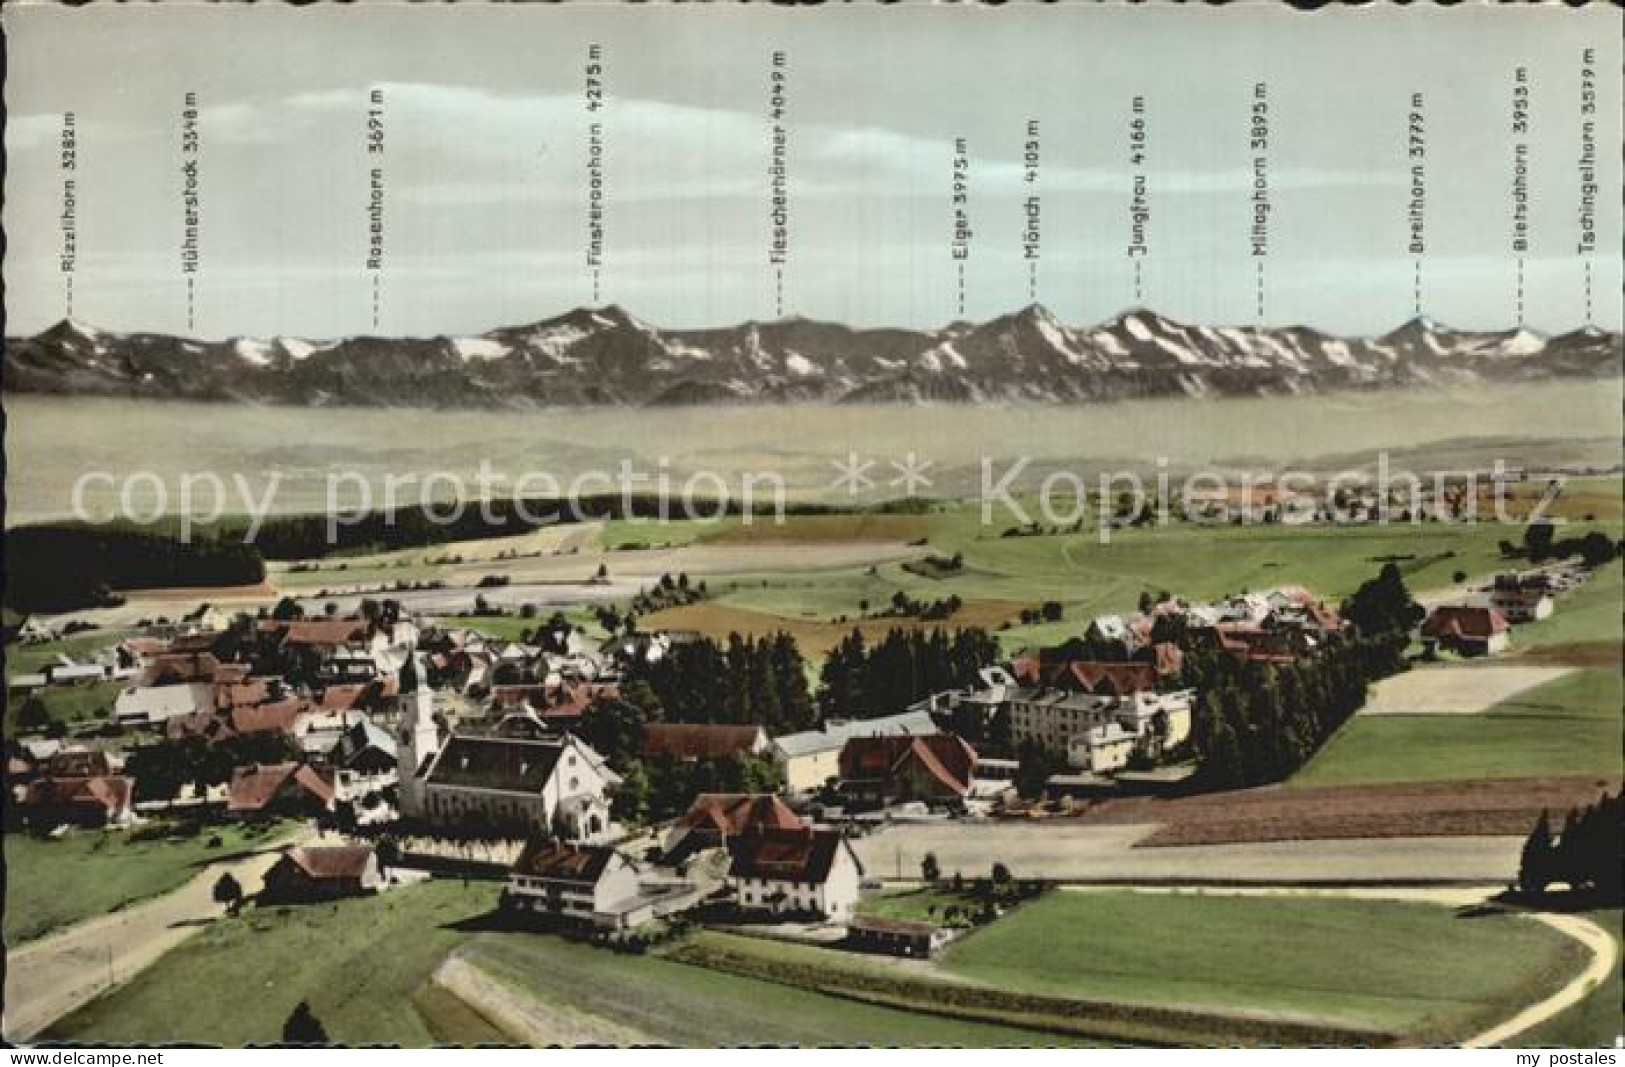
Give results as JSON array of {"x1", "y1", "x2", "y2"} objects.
[{"x1": 853, "y1": 822, "x2": 1523, "y2": 883}]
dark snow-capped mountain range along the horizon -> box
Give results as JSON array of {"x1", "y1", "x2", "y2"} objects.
[{"x1": 5, "y1": 304, "x2": 1622, "y2": 408}]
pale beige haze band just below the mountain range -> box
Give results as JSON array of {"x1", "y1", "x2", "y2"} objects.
[{"x1": 7, "y1": 377, "x2": 1625, "y2": 522}]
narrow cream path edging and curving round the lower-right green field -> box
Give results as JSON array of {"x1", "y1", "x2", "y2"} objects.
[{"x1": 1066, "y1": 885, "x2": 1620, "y2": 1049}]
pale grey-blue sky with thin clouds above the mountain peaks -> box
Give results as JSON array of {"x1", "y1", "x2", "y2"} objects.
[{"x1": 3, "y1": 5, "x2": 1622, "y2": 338}]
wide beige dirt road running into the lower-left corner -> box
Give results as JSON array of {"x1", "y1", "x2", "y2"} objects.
[{"x1": 3, "y1": 830, "x2": 315, "y2": 1043}]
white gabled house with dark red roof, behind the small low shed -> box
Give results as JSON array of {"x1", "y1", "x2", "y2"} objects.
[{"x1": 728, "y1": 828, "x2": 863, "y2": 922}]
